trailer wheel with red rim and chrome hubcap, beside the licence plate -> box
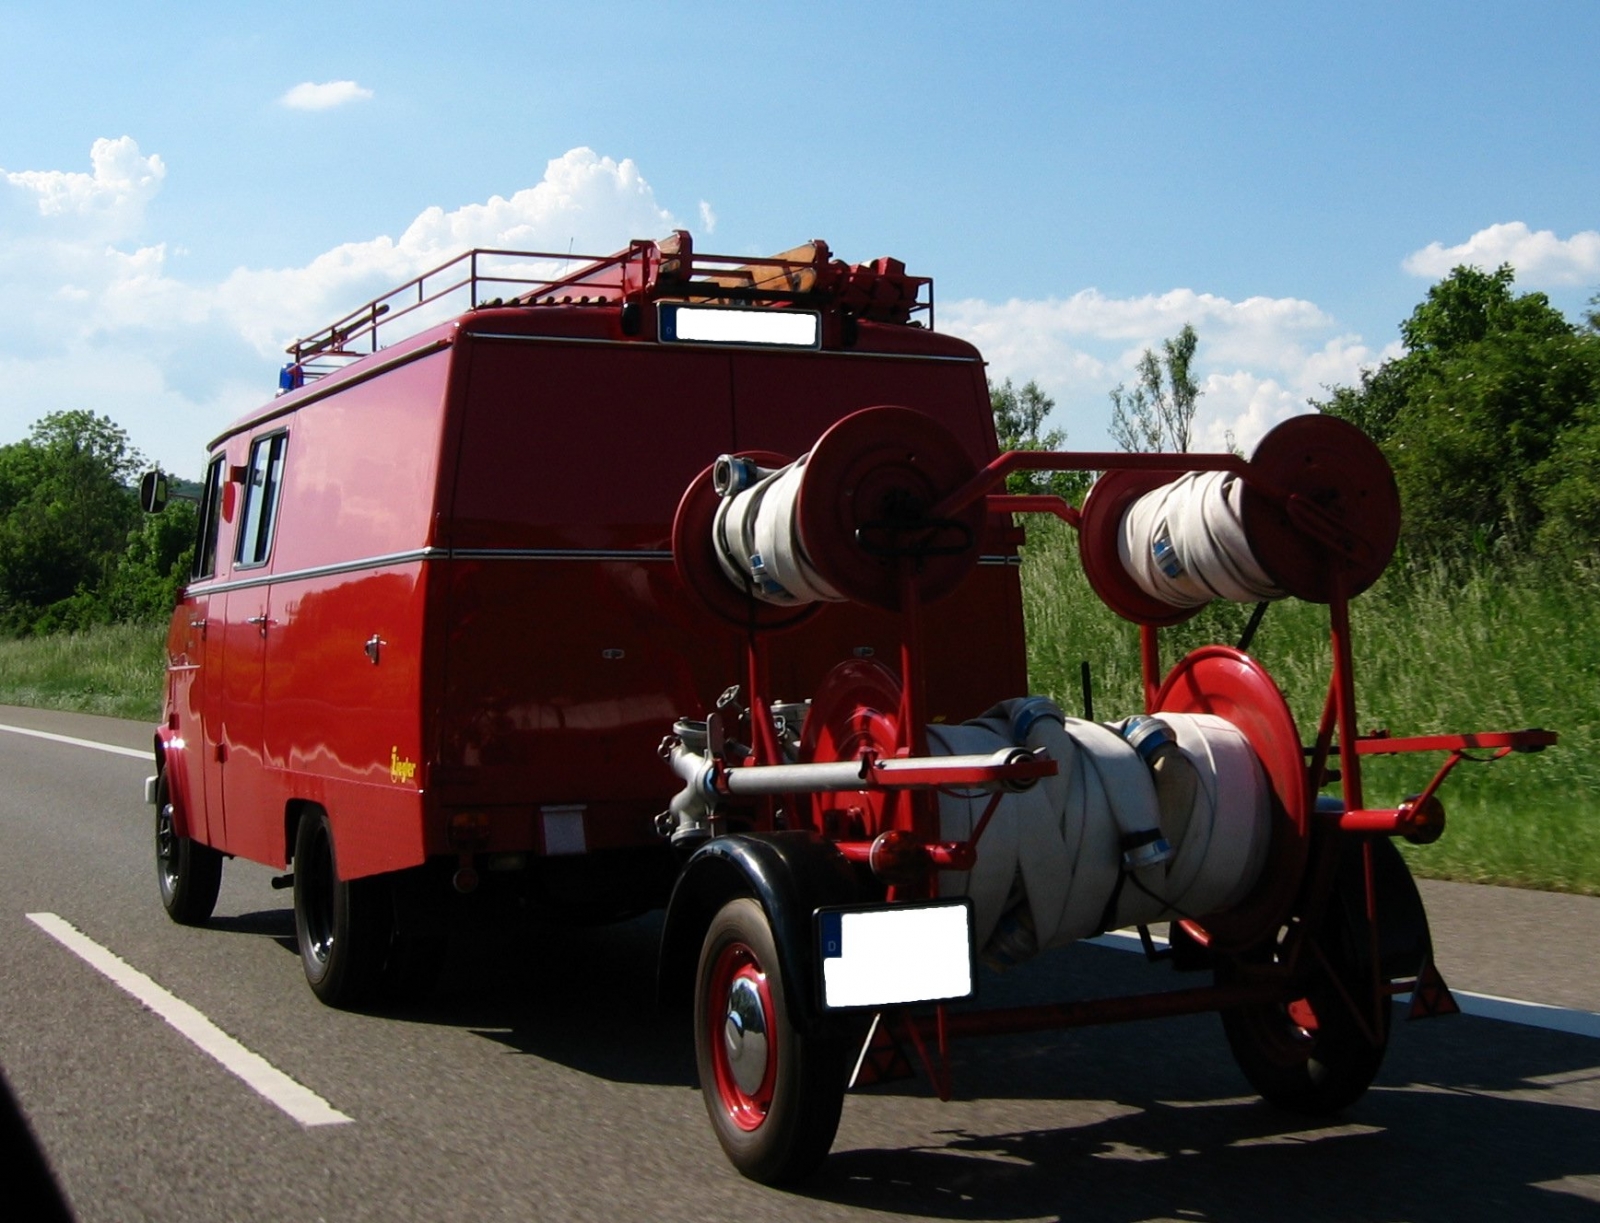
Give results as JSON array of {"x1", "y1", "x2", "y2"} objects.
[{"x1": 694, "y1": 898, "x2": 845, "y2": 1185}]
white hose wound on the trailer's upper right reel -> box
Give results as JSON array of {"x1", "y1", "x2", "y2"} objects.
[{"x1": 1117, "y1": 471, "x2": 1286, "y2": 608}]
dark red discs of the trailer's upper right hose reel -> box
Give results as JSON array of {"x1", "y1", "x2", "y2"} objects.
[{"x1": 1078, "y1": 413, "x2": 1400, "y2": 628}]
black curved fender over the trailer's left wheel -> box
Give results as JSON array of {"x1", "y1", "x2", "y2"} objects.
[{"x1": 656, "y1": 832, "x2": 870, "y2": 1033}]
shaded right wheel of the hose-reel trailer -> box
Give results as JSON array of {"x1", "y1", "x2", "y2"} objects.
[{"x1": 1216, "y1": 922, "x2": 1390, "y2": 1116}]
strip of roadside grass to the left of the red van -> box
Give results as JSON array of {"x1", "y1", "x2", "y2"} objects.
[{"x1": 0, "y1": 624, "x2": 166, "y2": 722}]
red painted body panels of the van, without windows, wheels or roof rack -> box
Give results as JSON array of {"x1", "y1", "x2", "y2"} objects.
[{"x1": 162, "y1": 248, "x2": 1026, "y2": 896}]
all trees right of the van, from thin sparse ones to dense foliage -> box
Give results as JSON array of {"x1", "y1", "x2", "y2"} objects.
[{"x1": 989, "y1": 266, "x2": 1600, "y2": 568}]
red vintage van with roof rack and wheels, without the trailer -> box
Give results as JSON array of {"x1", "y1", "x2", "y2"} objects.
[{"x1": 150, "y1": 232, "x2": 1026, "y2": 1005}]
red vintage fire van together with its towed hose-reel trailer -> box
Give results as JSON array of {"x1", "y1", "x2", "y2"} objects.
[{"x1": 149, "y1": 232, "x2": 1554, "y2": 1181}]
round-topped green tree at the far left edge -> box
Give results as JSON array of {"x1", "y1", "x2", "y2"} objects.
[{"x1": 0, "y1": 410, "x2": 142, "y2": 632}]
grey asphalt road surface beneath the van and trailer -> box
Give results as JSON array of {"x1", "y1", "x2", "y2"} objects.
[{"x1": 0, "y1": 709, "x2": 1600, "y2": 1223}]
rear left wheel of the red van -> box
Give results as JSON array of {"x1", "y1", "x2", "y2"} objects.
[{"x1": 294, "y1": 812, "x2": 394, "y2": 1008}]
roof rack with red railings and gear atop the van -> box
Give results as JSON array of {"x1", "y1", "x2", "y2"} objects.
[{"x1": 282, "y1": 229, "x2": 933, "y2": 389}]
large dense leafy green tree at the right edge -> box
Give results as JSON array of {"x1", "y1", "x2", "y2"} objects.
[{"x1": 1315, "y1": 266, "x2": 1600, "y2": 555}]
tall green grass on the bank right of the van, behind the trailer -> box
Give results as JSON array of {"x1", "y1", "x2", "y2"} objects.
[{"x1": 1022, "y1": 520, "x2": 1600, "y2": 895}]
